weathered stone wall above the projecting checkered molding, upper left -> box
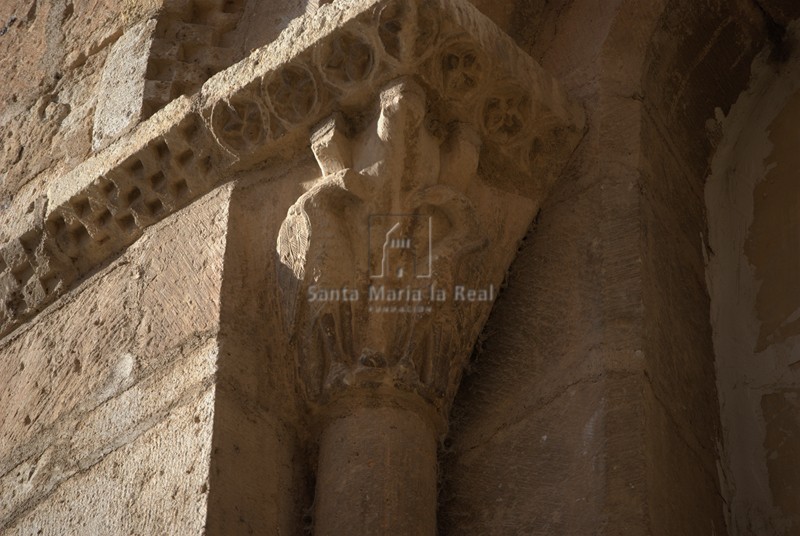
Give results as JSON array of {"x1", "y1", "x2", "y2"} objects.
[{"x1": 0, "y1": 0, "x2": 296, "y2": 242}]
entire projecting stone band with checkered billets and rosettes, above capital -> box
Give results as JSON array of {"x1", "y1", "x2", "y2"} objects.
[{"x1": 0, "y1": 0, "x2": 583, "y2": 352}]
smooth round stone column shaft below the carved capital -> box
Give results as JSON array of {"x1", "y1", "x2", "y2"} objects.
[{"x1": 314, "y1": 404, "x2": 437, "y2": 536}]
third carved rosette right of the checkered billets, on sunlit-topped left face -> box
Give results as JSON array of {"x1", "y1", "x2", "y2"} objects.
[{"x1": 319, "y1": 32, "x2": 376, "y2": 90}]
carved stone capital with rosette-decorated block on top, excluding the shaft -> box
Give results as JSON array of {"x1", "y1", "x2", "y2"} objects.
[{"x1": 268, "y1": 2, "x2": 583, "y2": 428}]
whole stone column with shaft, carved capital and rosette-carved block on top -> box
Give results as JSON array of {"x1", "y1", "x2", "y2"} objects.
[{"x1": 266, "y1": 0, "x2": 583, "y2": 536}]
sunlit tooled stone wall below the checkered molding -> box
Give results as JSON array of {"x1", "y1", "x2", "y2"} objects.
[{"x1": 0, "y1": 183, "x2": 230, "y2": 534}]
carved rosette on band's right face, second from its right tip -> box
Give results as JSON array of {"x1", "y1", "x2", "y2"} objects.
[{"x1": 482, "y1": 86, "x2": 531, "y2": 144}]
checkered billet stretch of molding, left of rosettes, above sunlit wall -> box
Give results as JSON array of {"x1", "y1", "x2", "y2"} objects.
[{"x1": 0, "y1": 115, "x2": 213, "y2": 336}]
